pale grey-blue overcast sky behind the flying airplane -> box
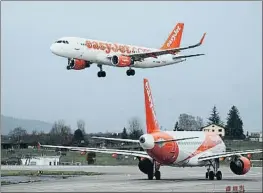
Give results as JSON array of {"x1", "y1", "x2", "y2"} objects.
[{"x1": 1, "y1": 1, "x2": 262, "y2": 132}]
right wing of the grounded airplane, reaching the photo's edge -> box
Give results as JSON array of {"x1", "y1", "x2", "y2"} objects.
[{"x1": 198, "y1": 149, "x2": 262, "y2": 161}]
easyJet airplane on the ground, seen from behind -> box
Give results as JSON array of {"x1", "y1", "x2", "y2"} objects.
[{"x1": 38, "y1": 79, "x2": 262, "y2": 180}]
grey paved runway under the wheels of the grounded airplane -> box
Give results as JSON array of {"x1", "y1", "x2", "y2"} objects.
[{"x1": 1, "y1": 166, "x2": 262, "y2": 192}]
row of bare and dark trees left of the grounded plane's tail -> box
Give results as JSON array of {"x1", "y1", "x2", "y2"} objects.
[{"x1": 4, "y1": 117, "x2": 143, "y2": 146}]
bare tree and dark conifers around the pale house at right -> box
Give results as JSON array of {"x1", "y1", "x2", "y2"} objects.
[{"x1": 174, "y1": 106, "x2": 245, "y2": 139}]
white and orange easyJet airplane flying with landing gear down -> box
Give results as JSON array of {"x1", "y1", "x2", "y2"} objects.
[{"x1": 50, "y1": 23, "x2": 206, "y2": 77}]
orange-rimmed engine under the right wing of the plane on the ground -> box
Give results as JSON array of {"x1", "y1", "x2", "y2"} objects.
[{"x1": 230, "y1": 156, "x2": 251, "y2": 175}]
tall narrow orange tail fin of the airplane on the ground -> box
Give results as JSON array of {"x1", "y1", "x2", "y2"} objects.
[{"x1": 143, "y1": 79, "x2": 160, "y2": 133}]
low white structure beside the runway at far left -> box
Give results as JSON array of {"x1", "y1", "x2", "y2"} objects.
[{"x1": 21, "y1": 156, "x2": 60, "y2": 166}]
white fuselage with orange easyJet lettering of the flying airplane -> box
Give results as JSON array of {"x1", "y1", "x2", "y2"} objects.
[{"x1": 50, "y1": 37, "x2": 185, "y2": 68}]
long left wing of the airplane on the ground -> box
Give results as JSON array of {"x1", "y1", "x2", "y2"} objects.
[{"x1": 38, "y1": 143, "x2": 152, "y2": 159}]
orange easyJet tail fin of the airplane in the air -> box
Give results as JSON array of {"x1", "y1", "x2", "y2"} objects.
[{"x1": 161, "y1": 23, "x2": 184, "y2": 50}]
